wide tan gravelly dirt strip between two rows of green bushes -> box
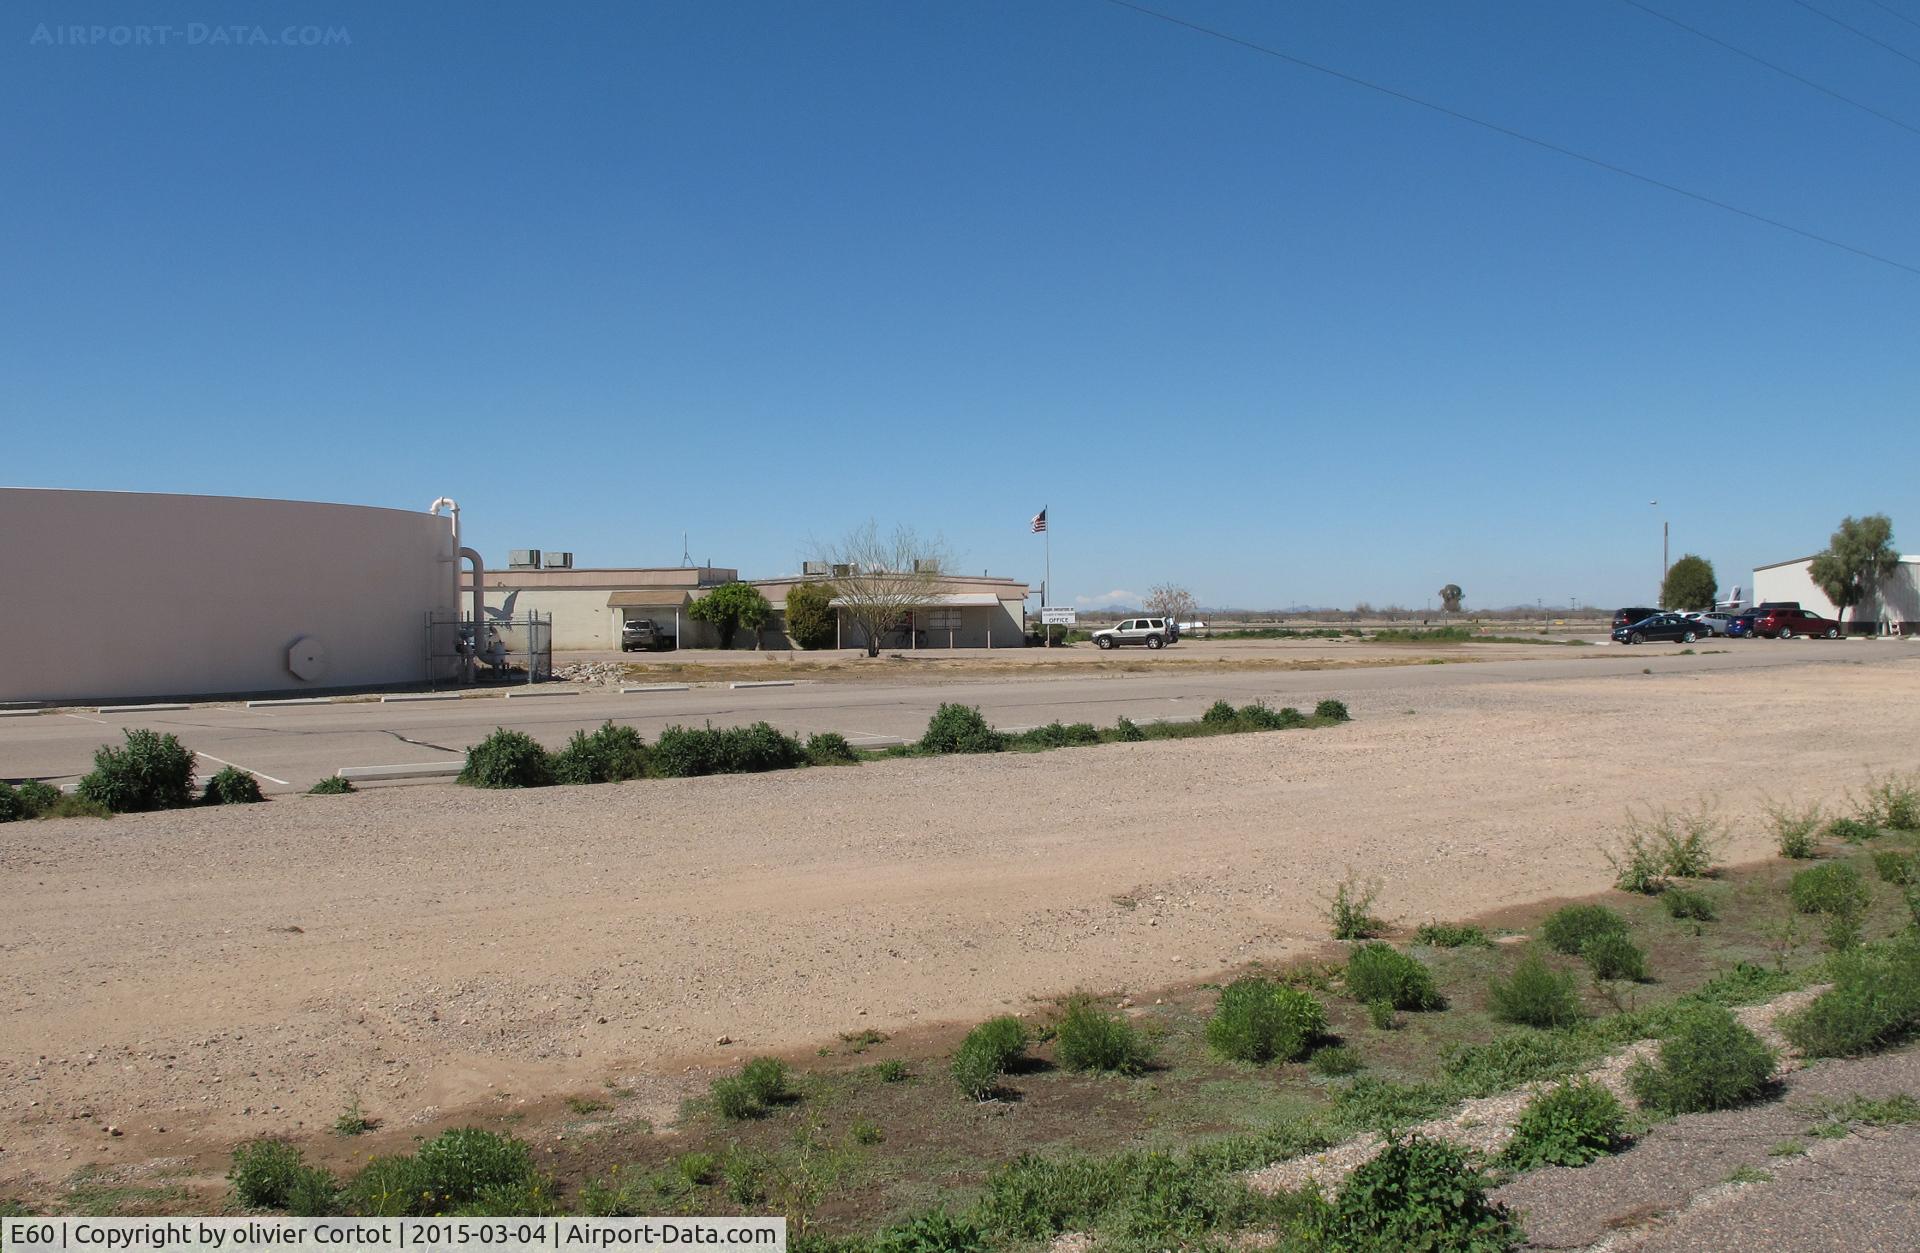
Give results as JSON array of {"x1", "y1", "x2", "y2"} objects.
[{"x1": 0, "y1": 658, "x2": 1920, "y2": 1195}]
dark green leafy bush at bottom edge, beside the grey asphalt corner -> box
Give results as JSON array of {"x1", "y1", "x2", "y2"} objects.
[{"x1": 1325, "y1": 1136, "x2": 1519, "y2": 1251}]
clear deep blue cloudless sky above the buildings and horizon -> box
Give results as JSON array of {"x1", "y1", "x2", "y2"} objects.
[{"x1": 0, "y1": 0, "x2": 1920, "y2": 606}]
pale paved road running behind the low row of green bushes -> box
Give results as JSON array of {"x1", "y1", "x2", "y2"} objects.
[{"x1": 0, "y1": 641, "x2": 1920, "y2": 792}]
